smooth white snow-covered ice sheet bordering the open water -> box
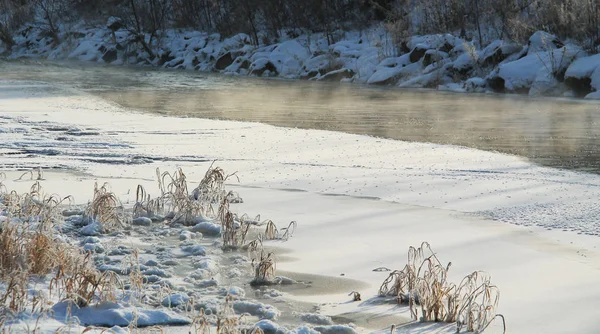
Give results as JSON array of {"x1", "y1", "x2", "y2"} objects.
[{"x1": 0, "y1": 81, "x2": 600, "y2": 333}]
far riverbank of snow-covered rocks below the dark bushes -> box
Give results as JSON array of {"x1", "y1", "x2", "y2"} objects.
[{"x1": 0, "y1": 21, "x2": 600, "y2": 99}]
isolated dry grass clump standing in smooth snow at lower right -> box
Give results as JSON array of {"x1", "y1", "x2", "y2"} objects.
[{"x1": 379, "y1": 242, "x2": 506, "y2": 332}]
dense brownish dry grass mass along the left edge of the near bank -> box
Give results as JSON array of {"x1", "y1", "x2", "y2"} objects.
[{"x1": 0, "y1": 182, "x2": 123, "y2": 313}]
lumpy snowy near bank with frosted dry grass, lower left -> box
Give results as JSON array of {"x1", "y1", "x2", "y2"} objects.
[{"x1": 0, "y1": 165, "x2": 328, "y2": 333}]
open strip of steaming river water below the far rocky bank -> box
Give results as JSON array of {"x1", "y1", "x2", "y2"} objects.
[{"x1": 0, "y1": 61, "x2": 600, "y2": 173}]
